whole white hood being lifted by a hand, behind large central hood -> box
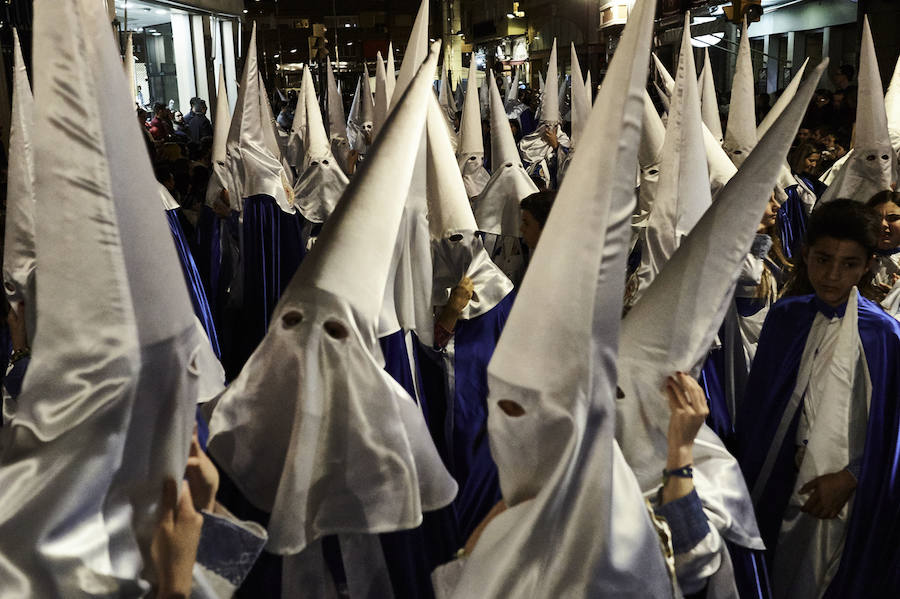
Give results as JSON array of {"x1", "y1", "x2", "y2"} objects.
[{"x1": 426, "y1": 95, "x2": 513, "y2": 319}]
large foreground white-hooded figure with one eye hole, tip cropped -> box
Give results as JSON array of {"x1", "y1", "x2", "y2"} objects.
[{"x1": 439, "y1": 1, "x2": 674, "y2": 599}]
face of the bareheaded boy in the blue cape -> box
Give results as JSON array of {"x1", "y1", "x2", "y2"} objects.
[{"x1": 803, "y1": 237, "x2": 872, "y2": 306}]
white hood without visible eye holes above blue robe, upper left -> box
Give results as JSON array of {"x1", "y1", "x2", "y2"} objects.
[{"x1": 228, "y1": 23, "x2": 296, "y2": 213}]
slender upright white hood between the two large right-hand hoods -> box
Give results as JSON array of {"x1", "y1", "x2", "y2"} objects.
[{"x1": 626, "y1": 13, "x2": 712, "y2": 305}]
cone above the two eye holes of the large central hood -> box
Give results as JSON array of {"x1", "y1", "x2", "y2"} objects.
[{"x1": 291, "y1": 41, "x2": 438, "y2": 326}]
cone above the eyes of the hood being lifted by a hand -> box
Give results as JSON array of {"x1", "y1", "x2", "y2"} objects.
[{"x1": 426, "y1": 99, "x2": 478, "y2": 239}]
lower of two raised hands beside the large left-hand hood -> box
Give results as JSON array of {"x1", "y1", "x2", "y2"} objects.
[{"x1": 150, "y1": 478, "x2": 203, "y2": 599}]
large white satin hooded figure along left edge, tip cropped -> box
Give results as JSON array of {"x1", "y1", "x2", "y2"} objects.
[{"x1": 0, "y1": 2, "x2": 208, "y2": 597}]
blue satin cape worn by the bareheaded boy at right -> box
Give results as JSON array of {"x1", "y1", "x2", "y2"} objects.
[{"x1": 737, "y1": 295, "x2": 900, "y2": 597}]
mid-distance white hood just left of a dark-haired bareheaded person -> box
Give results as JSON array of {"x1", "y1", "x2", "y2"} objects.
[{"x1": 475, "y1": 72, "x2": 538, "y2": 237}]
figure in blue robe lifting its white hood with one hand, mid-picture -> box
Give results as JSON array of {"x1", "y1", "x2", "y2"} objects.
[{"x1": 426, "y1": 95, "x2": 513, "y2": 539}]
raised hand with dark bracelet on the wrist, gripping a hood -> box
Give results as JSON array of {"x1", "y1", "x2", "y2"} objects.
[{"x1": 663, "y1": 372, "x2": 709, "y2": 469}]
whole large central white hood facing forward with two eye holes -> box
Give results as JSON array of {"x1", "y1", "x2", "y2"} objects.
[{"x1": 209, "y1": 41, "x2": 456, "y2": 557}]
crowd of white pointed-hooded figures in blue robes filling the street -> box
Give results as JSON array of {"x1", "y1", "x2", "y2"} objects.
[{"x1": 0, "y1": 0, "x2": 900, "y2": 599}]
